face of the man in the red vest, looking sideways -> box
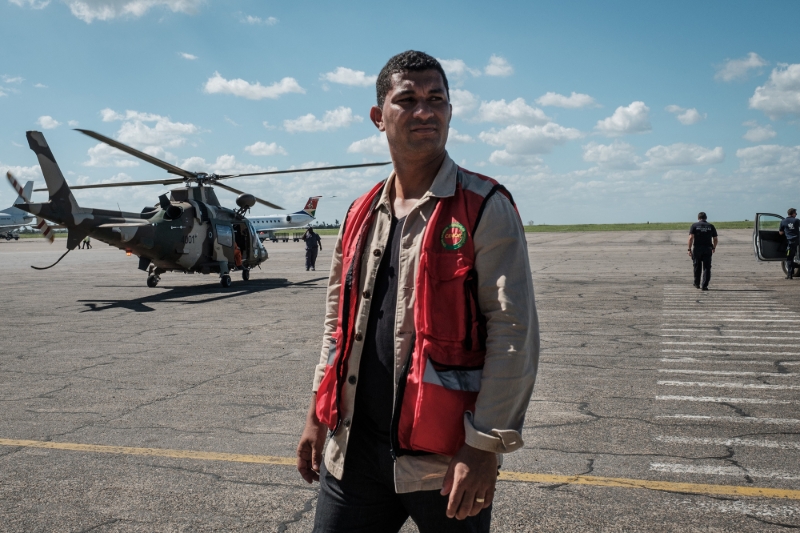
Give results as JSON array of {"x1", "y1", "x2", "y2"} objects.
[{"x1": 370, "y1": 69, "x2": 452, "y2": 158}]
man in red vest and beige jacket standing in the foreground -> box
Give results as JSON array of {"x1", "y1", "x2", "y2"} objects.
[{"x1": 297, "y1": 51, "x2": 539, "y2": 532}]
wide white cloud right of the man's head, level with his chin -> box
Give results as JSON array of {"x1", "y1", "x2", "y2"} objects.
[{"x1": 479, "y1": 122, "x2": 583, "y2": 161}]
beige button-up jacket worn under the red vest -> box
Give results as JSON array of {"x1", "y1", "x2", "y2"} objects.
[{"x1": 313, "y1": 153, "x2": 539, "y2": 493}]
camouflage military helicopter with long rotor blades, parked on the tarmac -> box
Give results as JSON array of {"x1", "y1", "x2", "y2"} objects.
[{"x1": 8, "y1": 130, "x2": 389, "y2": 288}]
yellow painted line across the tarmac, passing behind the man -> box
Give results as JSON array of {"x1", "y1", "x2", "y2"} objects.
[{"x1": 0, "y1": 439, "x2": 800, "y2": 500}]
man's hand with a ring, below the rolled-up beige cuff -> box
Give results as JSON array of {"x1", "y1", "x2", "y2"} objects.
[{"x1": 441, "y1": 444, "x2": 497, "y2": 520}]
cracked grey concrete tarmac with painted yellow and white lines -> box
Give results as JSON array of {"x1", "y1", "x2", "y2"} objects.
[{"x1": 0, "y1": 228, "x2": 800, "y2": 533}]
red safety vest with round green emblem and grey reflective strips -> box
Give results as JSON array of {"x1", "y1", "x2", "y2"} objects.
[{"x1": 316, "y1": 168, "x2": 513, "y2": 456}]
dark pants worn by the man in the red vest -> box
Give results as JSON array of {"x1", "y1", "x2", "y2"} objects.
[{"x1": 314, "y1": 424, "x2": 492, "y2": 533}]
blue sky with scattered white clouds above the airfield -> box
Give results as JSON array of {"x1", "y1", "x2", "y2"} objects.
[{"x1": 0, "y1": 0, "x2": 800, "y2": 224}]
